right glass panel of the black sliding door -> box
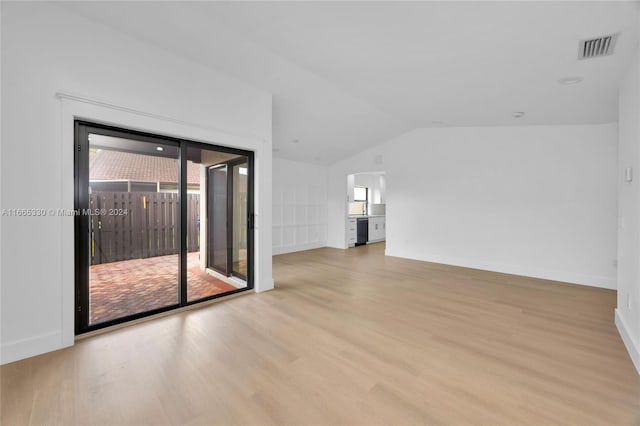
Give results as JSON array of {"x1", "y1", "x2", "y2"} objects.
[{"x1": 187, "y1": 146, "x2": 248, "y2": 302}]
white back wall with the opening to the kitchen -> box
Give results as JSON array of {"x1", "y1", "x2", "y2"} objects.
[{"x1": 328, "y1": 124, "x2": 617, "y2": 288}]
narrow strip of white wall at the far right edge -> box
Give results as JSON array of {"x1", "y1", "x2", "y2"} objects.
[{"x1": 616, "y1": 19, "x2": 640, "y2": 372}]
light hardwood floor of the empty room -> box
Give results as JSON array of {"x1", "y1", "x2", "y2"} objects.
[{"x1": 0, "y1": 244, "x2": 640, "y2": 426}]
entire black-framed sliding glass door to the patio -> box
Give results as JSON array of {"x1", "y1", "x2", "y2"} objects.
[{"x1": 75, "y1": 122, "x2": 253, "y2": 333}]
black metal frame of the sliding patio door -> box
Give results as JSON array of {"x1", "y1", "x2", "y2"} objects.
[{"x1": 74, "y1": 120, "x2": 255, "y2": 335}]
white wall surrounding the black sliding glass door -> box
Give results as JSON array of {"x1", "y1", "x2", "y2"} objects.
[{"x1": 0, "y1": 2, "x2": 273, "y2": 363}]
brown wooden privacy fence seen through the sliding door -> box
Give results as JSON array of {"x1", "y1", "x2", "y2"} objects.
[{"x1": 89, "y1": 191, "x2": 200, "y2": 265}]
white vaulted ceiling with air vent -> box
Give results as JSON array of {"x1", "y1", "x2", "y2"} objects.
[{"x1": 57, "y1": 1, "x2": 640, "y2": 164}]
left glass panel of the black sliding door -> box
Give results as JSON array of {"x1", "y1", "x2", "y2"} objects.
[{"x1": 84, "y1": 133, "x2": 180, "y2": 326}]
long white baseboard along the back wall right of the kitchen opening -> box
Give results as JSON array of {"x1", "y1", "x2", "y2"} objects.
[{"x1": 385, "y1": 248, "x2": 617, "y2": 290}]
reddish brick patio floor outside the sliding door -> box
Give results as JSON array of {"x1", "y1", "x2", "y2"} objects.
[{"x1": 89, "y1": 252, "x2": 241, "y2": 324}]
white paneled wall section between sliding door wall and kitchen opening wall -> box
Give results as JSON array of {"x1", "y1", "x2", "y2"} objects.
[{"x1": 273, "y1": 158, "x2": 327, "y2": 254}]
